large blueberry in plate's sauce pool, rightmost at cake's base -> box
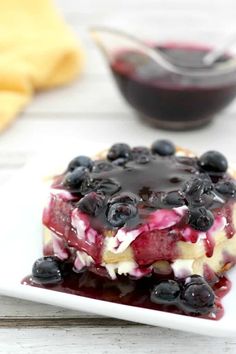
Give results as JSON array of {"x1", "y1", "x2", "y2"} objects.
[{"x1": 181, "y1": 278, "x2": 215, "y2": 314}]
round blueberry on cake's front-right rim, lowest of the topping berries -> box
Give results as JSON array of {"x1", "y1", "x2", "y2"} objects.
[{"x1": 189, "y1": 207, "x2": 214, "y2": 231}]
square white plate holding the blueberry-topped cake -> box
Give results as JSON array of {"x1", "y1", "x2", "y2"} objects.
[{"x1": 0, "y1": 149, "x2": 236, "y2": 336}]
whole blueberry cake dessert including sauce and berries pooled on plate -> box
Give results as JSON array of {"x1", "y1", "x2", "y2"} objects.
[{"x1": 23, "y1": 140, "x2": 236, "y2": 318}]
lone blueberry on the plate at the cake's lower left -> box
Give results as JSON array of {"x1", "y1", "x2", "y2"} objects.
[{"x1": 32, "y1": 256, "x2": 62, "y2": 284}]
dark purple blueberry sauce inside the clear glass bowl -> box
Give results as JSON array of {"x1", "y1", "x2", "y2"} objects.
[{"x1": 111, "y1": 43, "x2": 236, "y2": 129}]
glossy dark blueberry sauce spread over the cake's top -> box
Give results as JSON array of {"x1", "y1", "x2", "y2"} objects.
[{"x1": 49, "y1": 155, "x2": 199, "y2": 230}]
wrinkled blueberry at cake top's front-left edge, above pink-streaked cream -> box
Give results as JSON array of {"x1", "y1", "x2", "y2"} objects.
[{"x1": 76, "y1": 192, "x2": 105, "y2": 216}]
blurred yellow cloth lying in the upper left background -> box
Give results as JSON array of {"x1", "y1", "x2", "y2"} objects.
[{"x1": 0, "y1": 0, "x2": 83, "y2": 131}]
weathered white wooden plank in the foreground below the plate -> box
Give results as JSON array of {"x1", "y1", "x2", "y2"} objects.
[{"x1": 0, "y1": 324, "x2": 236, "y2": 354}]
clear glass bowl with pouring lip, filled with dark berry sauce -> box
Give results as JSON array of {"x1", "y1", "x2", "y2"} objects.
[{"x1": 91, "y1": 20, "x2": 236, "y2": 130}]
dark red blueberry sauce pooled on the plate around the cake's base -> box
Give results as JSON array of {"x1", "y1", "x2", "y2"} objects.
[{"x1": 22, "y1": 271, "x2": 231, "y2": 320}]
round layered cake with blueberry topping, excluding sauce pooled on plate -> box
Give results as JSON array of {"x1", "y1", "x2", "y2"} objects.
[{"x1": 43, "y1": 140, "x2": 236, "y2": 282}]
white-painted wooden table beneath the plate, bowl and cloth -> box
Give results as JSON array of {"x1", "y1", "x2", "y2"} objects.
[{"x1": 0, "y1": 0, "x2": 236, "y2": 354}]
